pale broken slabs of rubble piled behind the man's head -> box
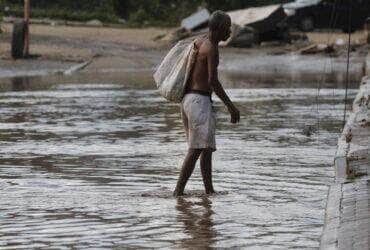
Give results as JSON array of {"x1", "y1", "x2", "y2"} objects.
[{"x1": 157, "y1": 4, "x2": 289, "y2": 47}]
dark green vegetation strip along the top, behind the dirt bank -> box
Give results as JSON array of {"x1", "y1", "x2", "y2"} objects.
[{"x1": 0, "y1": 0, "x2": 289, "y2": 26}]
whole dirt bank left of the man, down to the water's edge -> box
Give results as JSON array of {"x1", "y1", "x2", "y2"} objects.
[{"x1": 0, "y1": 24, "x2": 172, "y2": 77}]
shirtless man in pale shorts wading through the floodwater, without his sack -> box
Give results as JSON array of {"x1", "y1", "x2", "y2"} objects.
[{"x1": 174, "y1": 11, "x2": 240, "y2": 196}]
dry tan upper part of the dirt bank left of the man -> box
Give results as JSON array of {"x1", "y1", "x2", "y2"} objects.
[{"x1": 0, "y1": 24, "x2": 168, "y2": 61}]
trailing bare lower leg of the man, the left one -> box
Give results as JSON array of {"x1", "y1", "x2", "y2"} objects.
[{"x1": 173, "y1": 148, "x2": 202, "y2": 196}]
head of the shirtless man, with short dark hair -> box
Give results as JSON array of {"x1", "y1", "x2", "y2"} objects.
[{"x1": 208, "y1": 10, "x2": 231, "y2": 41}]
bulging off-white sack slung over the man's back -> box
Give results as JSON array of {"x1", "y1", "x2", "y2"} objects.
[{"x1": 153, "y1": 40, "x2": 198, "y2": 102}]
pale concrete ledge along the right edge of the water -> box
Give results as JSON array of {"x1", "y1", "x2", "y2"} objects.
[{"x1": 320, "y1": 65, "x2": 370, "y2": 250}]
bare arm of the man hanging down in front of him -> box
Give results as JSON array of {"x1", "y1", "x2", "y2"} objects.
[{"x1": 207, "y1": 45, "x2": 240, "y2": 123}]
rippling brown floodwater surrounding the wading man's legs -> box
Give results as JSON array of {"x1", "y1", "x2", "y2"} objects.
[{"x1": 0, "y1": 77, "x2": 355, "y2": 249}]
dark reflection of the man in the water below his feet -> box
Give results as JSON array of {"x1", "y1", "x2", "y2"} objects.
[{"x1": 176, "y1": 196, "x2": 216, "y2": 249}]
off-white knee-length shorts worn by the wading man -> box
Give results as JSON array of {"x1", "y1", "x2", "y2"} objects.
[{"x1": 181, "y1": 93, "x2": 216, "y2": 151}]
